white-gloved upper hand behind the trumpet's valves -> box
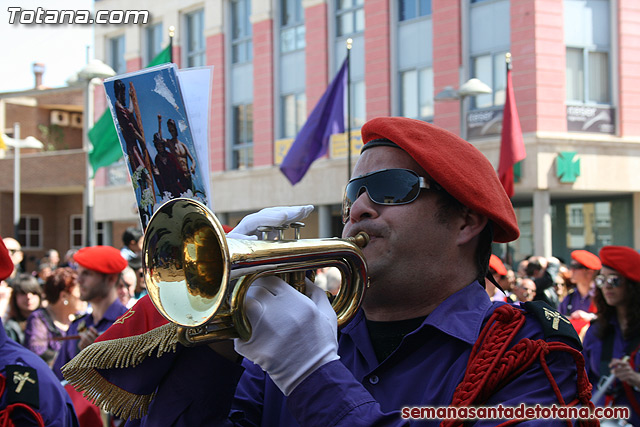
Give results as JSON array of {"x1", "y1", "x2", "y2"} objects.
[{"x1": 227, "y1": 205, "x2": 313, "y2": 240}]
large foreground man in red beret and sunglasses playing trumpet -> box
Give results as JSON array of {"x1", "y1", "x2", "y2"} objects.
[{"x1": 65, "y1": 117, "x2": 590, "y2": 426}]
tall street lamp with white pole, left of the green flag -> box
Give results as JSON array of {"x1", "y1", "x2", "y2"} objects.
[{"x1": 78, "y1": 59, "x2": 116, "y2": 246}]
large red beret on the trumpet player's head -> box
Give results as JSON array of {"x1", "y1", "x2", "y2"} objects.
[{"x1": 361, "y1": 117, "x2": 520, "y2": 242}]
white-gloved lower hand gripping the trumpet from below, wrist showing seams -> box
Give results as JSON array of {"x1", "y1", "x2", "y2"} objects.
[{"x1": 234, "y1": 276, "x2": 340, "y2": 396}]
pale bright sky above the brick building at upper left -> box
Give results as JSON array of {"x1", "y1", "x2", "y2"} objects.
[{"x1": 0, "y1": 0, "x2": 93, "y2": 92}]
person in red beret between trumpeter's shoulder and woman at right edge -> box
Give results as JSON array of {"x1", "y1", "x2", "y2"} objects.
[{"x1": 558, "y1": 249, "x2": 602, "y2": 335}]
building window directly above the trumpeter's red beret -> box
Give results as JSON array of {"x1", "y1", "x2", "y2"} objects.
[{"x1": 400, "y1": 68, "x2": 433, "y2": 120}]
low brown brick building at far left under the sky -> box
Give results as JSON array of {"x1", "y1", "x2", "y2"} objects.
[{"x1": 0, "y1": 70, "x2": 86, "y2": 271}]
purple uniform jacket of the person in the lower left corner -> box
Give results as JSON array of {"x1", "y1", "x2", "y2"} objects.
[{"x1": 0, "y1": 321, "x2": 78, "y2": 427}]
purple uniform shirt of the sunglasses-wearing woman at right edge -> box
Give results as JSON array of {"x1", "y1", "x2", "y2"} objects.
[{"x1": 582, "y1": 319, "x2": 640, "y2": 426}]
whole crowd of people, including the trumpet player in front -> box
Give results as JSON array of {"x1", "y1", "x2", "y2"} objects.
[{"x1": 0, "y1": 117, "x2": 640, "y2": 426}]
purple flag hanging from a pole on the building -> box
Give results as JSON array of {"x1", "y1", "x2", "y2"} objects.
[{"x1": 280, "y1": 58, "x2": 348, "y2": 185}]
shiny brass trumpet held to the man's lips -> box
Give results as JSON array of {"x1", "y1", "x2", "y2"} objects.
[{"x1": 143, "y1": 198, "x2": 369, "y2": 346}]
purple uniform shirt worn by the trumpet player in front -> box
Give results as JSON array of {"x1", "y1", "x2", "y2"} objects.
[{"x1": 127, "y1": 282, "x2": 576, "y2": 427}]
